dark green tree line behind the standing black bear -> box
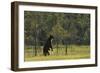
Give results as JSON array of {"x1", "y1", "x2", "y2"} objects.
[{"x1": 24, "y1": 11, "x2": 90, "y2": 45}]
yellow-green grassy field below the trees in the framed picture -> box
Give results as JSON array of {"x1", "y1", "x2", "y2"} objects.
[{"x1": 24, "y1": 45, "x2": 90, "y2": 61}]
